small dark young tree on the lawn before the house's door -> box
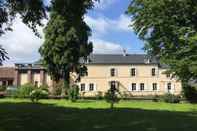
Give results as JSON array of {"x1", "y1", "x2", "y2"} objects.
[{"x1": 104, "y1": 88, "x2": 120, "y2": 109}]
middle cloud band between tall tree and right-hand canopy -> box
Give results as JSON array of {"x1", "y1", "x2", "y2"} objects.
[{"x1": 85, "y1": 14, "x2": 132, "y2": 35}]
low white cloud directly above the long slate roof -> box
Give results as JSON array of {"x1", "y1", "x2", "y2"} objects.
[{"x1": 91, "y1": 39, "x2": 123, "y2": 54}]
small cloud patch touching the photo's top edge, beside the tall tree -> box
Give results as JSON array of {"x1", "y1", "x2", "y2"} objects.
[{"x1": 95, "y1": 0, "x2": 117, "y2": 10}]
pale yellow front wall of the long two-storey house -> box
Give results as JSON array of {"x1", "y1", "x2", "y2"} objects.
[{"x1": 78, "y1": 65, "x2": 181, "y2": 95}]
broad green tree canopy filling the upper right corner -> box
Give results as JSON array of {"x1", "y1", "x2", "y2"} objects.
[{"x1": 127, "y1": 0, "x2": 197, "y2": 81}]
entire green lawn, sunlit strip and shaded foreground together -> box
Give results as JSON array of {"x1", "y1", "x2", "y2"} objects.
[{"x1": 0, "y1": 99, "x2": 197, "y2": 131}]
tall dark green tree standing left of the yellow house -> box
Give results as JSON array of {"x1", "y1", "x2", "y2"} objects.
[{"x1": 39, "y1": 0, "x2": 94, "y2": 94}]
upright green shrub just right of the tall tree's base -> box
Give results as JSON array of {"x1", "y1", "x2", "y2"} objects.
[{"x1": 68, "y1": 85, "x2": 79, "y2": 102}]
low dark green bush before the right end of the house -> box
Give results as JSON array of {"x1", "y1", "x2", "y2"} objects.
[{"x1": 163, "y1": 93, "x2": 181, "y2": 103}]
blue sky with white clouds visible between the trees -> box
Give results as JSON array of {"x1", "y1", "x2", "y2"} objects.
[{"x1": 0, "y1": 0, "x2": 144, "y2": 65}]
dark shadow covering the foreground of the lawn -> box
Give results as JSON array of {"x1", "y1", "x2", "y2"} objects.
[{"x1": 0, "y1": 103, "x2": 197, "y2": 131}]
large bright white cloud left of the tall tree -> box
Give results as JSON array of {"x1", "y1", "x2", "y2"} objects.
[{"x1": 0, "y1": 17, "x2": 46, "y2": 63}]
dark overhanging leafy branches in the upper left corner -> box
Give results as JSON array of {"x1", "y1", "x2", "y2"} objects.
[{"x1": 0, "y1": 0, "x2": 47, "y2": 64}]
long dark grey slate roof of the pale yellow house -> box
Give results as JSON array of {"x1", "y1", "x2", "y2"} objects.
[{"x1": 84, "y1": 54, "x2": 159, "y2": 64}]
